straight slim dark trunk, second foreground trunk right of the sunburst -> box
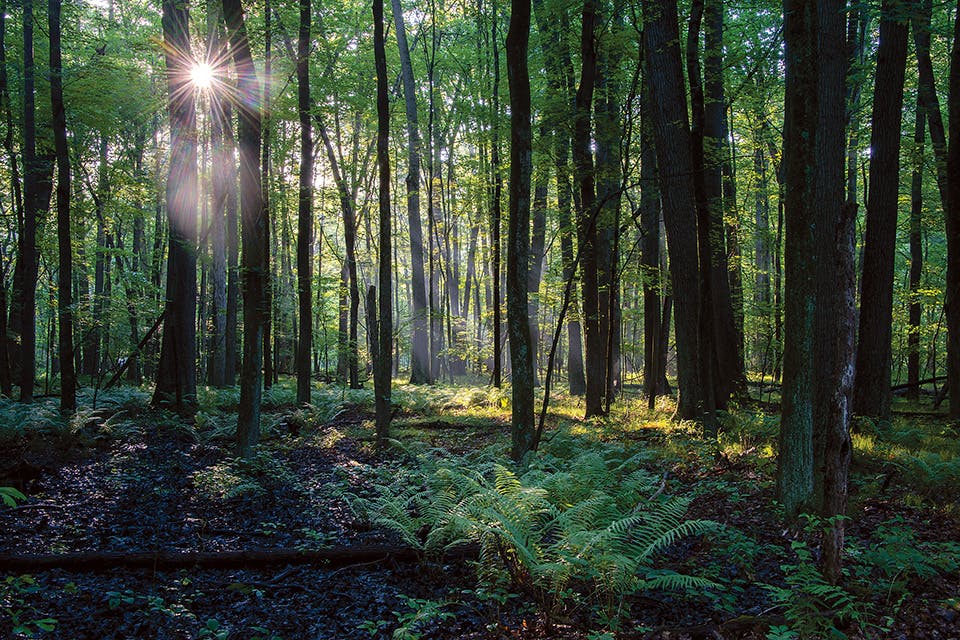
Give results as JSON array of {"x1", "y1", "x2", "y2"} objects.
[{"x1": 297, "y1": 0, "x2": 313, "y2": 404}]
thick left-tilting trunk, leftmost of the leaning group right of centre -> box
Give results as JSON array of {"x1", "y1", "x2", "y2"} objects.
[{"x1": 643, "y1": 0, "x2": 703, "y2": 419}]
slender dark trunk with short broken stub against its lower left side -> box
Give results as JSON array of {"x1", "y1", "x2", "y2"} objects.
[{"x1": 370, "y1": 0, "x2": 393, "y2": 447}]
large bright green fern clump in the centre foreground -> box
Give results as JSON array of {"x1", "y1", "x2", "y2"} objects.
[{"x1": 354, "y1": 438, "x2": 716, "y2": 627}]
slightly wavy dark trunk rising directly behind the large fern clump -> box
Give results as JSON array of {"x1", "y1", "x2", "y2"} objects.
[{"x1": 506, "y1": 0, "x2": 535, "y2": 462}]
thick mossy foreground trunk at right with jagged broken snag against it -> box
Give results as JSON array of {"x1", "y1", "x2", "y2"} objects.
[{"x1": 777, "y1": 0, "x2": 855, "y2": 582}]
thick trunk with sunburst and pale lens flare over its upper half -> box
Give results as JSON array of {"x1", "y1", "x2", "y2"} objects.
[{"x1": 153, "y1": 0, "x2": 197, "y2": 415}]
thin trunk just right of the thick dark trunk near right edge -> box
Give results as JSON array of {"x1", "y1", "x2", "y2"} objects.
[{"x1": 907, "y1": 104, "x2": 926, "y2": 400}]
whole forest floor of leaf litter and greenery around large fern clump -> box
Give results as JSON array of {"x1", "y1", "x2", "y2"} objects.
[{"x1": 0, "y1": 385, "x2": 960, "y2": 640}]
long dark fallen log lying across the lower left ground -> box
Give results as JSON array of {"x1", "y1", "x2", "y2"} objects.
[{"x1": 0, "y1": 545, "x2": 478, "y2": 572}]
